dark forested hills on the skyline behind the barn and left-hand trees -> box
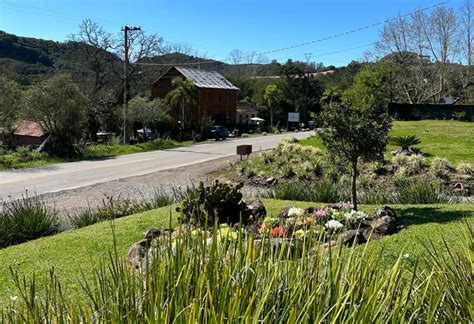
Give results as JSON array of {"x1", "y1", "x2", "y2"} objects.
[{"x1": 0, "y1": 31, "x2": 292, "y2": 85}]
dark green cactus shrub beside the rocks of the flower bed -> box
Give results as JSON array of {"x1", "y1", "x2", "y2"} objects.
[{"x1": 176, "y1": 180, "x2": 245, "y2": 226}]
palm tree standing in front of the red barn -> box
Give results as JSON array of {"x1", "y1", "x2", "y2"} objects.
[{"x1": 166, "y1": 77, "x2": 198, "y2": 123}]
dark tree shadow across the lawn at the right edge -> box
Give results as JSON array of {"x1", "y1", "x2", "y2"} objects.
[{"x1": 400, "y1": 207, "x2": 474, "y2": 225}]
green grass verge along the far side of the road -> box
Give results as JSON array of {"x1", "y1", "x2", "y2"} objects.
[{"x1": 0, "y1": 140, "x2": 192, "y2": 171}]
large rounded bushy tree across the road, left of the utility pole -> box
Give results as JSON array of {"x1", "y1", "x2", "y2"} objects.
[{"x1": 25, "y1": 74, "x2": 88, "y2": 156}]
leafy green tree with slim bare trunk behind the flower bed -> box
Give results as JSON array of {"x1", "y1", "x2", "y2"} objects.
[{"x1": 320, "y1": 67, "x2": 391, "y2": 209}]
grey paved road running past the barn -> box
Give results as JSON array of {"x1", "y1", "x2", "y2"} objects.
[{"x1": 0, "y1": 132, "x2": 310, "y2": 200}]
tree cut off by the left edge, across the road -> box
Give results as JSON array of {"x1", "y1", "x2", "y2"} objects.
[{"x1": 0, "y1": 77, "x2": 22, "y2": 147}]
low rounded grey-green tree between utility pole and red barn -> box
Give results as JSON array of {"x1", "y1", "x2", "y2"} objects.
[{"x1": 129, "y1": 96, "x2": 173, "y2": 136}]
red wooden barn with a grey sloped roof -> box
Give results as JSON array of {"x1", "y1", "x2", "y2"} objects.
[{"x1": 151, "y1": 66, "x2": 239, "y2": 127}]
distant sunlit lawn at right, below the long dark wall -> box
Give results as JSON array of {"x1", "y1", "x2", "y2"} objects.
[{"x1": 301, "y1": 120, "x2": 474, "y2": 166}]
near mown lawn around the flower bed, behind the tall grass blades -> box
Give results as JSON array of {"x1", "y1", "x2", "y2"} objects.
[{"x1": 0, "y1": 199, "x2": 474, "y2": 305}]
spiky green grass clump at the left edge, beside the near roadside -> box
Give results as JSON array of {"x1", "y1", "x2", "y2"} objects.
[{"x1": 0, "y1": 197, "x2": 62, "y2": 247}]
